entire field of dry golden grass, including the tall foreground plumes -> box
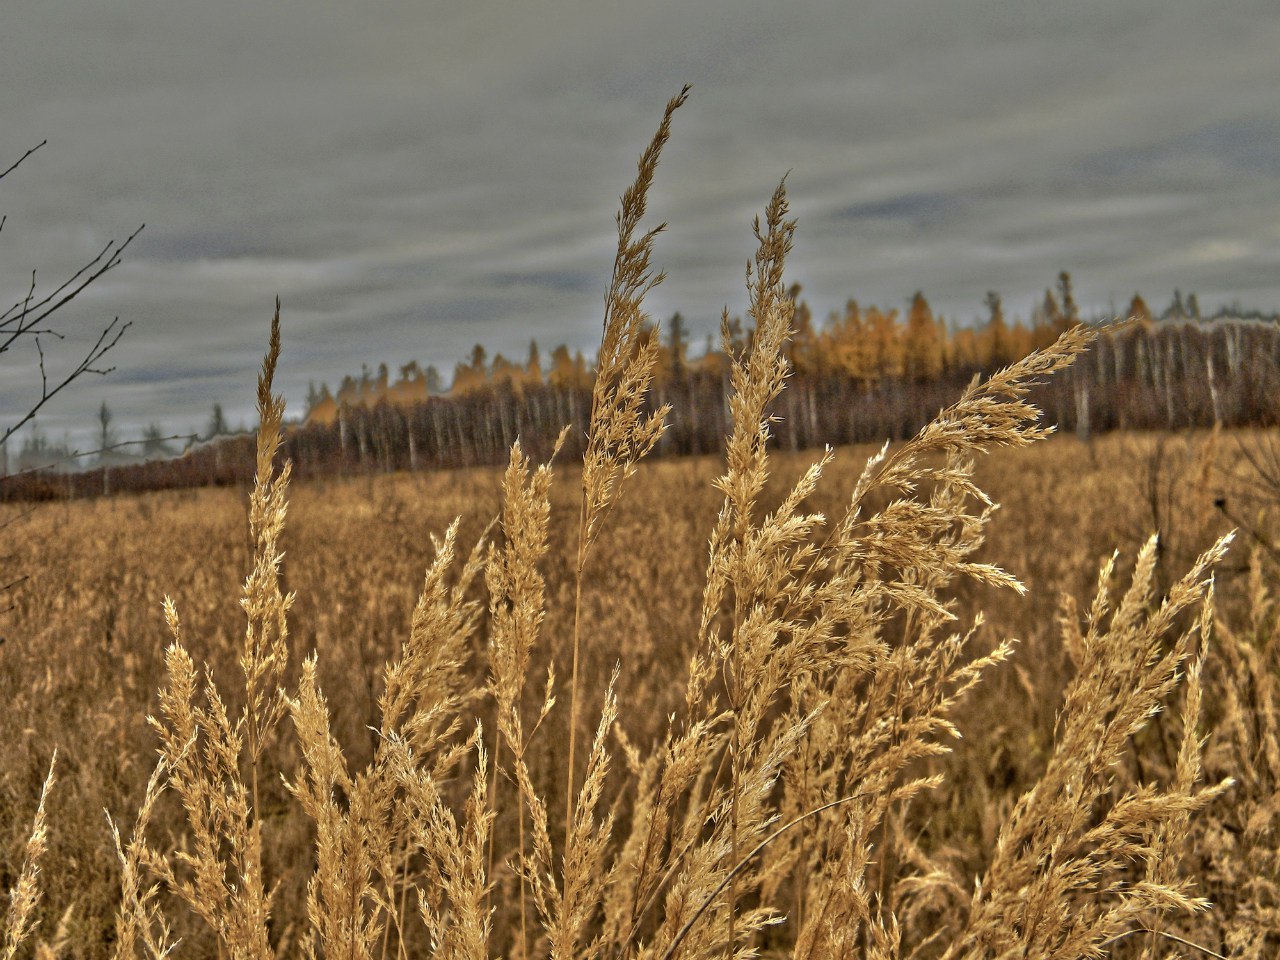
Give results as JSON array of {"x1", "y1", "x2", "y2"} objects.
[{"x1": 0, "y1": 86, "x2": 1280, "y2": 960}]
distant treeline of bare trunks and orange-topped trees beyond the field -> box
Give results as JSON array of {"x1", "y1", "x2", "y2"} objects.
[{"x1": 0, "y1": 273, "x2": 1280, "y2": 499}]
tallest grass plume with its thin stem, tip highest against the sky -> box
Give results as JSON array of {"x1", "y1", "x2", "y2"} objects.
[{"x1": 564, "y1": 84, "x2": 690, "y2": 836}]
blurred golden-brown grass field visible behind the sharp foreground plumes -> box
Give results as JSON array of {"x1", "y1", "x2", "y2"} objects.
[{"x1": 0, "y1": 414, "x2": 1275, "y2": 956}]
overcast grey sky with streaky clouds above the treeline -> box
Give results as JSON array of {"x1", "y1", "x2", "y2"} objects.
[{"x1": 0, "y1": 0, "x2": 1280, "y2": 443}]
